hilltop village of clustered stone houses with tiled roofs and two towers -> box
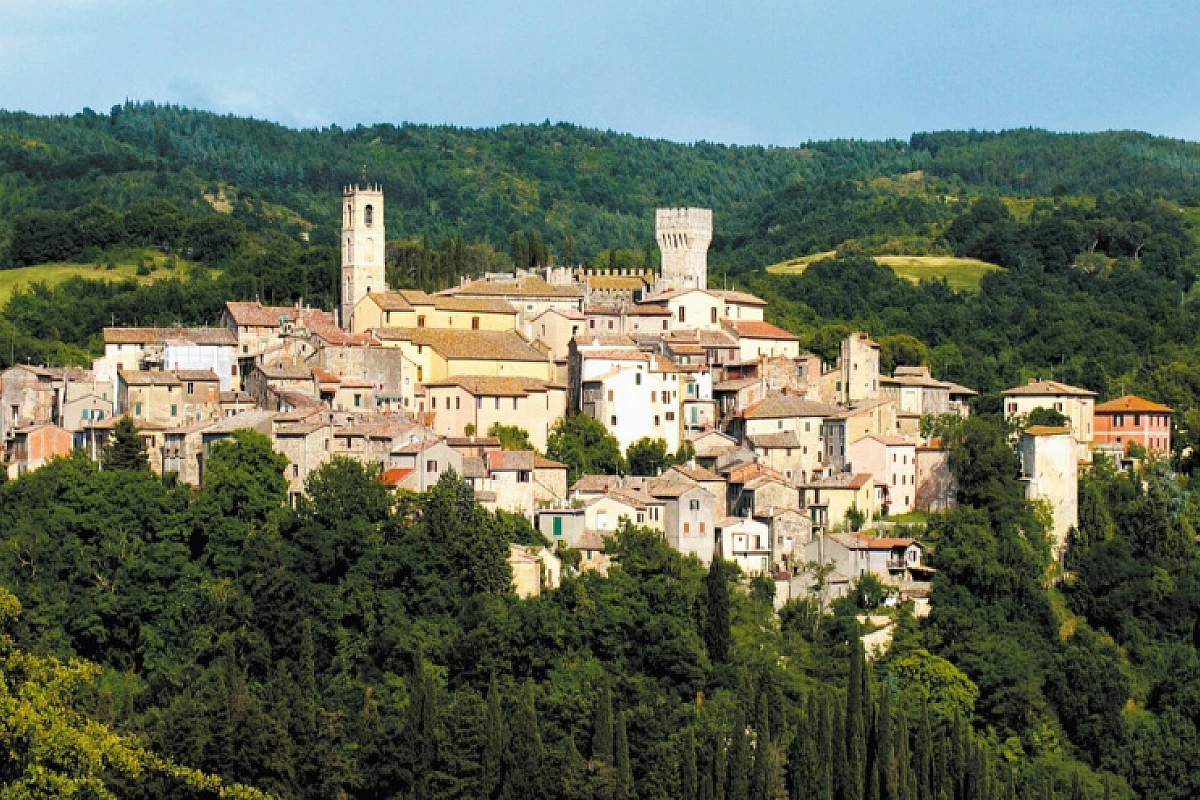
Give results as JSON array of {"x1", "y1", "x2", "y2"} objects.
[{"x1": 0, "y1": 186, "x2": 1171, "y2": 603}]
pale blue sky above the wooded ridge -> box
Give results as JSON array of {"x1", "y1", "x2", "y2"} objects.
[{"x1": 0, "y1": 0, "x2": 1200, "y2": 145}]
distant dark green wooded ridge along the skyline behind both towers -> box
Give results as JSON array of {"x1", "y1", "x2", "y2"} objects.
[{"x1": 0, "y1": 103, "x2": 1200, "y2": 269}]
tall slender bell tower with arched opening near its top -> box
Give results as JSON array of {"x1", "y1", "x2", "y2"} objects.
[{"x1": 340, "y1": 184, "x2": 388, "y2": 331}]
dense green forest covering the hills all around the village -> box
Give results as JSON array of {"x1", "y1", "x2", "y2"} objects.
[{"x1": 0, "y1": 103, "x2": 1200, "y2": 800}]
